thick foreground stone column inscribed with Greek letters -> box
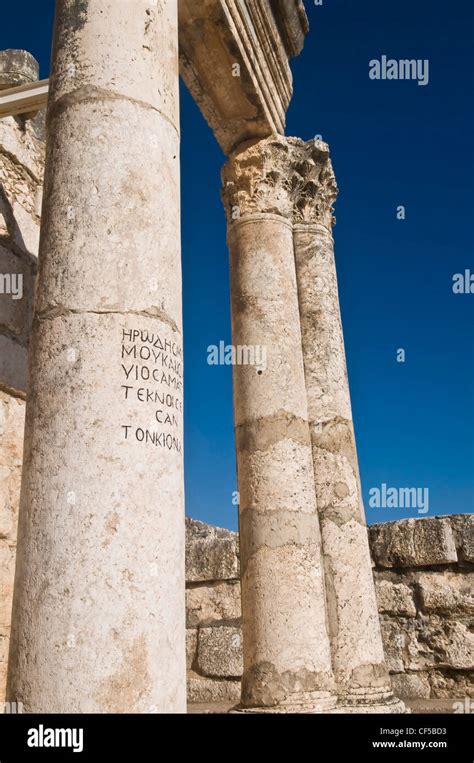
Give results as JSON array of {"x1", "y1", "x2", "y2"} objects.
[{"x1": 8, "y1": 0, "x2": 186, "y2": 713}]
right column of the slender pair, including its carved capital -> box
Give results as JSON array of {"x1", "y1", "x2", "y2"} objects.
[{"x1": 292, "y1": 139, "x2": 404, "y2": 712}]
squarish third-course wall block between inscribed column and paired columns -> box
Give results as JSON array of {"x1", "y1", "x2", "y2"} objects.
[{"x1": 197, "y1": 625, "x2": 244, "y2": 678}]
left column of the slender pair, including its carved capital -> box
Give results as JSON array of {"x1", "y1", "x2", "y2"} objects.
[{"x1": 223, "y1": 136, "x2": 335, "y2": 712}]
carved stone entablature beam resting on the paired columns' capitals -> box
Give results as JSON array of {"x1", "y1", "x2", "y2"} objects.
[{"x1": 178, "y1": 0, "x2": 309, "y2": 155}]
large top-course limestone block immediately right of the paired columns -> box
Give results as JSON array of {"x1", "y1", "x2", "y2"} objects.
[{"x1": 369, "y1": 517, "x2": 458, "y2": 567}]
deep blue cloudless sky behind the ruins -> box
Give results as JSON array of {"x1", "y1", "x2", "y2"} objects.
[{"x1": 0, "y1": 0, "x2": 474, "y2": 528}]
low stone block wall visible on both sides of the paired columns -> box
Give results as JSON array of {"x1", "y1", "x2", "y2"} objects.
[{"x1": 186, "y1": 514, "x2": 474, "y2": 703}]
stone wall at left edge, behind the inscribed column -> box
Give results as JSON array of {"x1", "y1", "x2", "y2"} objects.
[{"x1": 0, "y1": 91, "x2": 44, "y2": 698}]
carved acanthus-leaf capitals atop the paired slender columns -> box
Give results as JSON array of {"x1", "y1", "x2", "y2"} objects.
[{"x1": 222, "y1": 135, "x2": 337, "y2": 227}]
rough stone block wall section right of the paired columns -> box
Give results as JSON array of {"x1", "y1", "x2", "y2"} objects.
[{"x1": 370, "y1": 514, "x2": 474, "y2": 699}]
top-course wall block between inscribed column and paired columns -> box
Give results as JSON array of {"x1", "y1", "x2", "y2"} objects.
[{"x1": 186, "y1": 517, "x2": 239, "y2": 583}]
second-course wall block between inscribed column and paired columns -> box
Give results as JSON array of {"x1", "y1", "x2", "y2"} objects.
[{"x1": 186, "y1": 581, "x2": 241, "y2": 628}]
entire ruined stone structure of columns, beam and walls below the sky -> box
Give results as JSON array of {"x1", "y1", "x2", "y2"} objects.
[{"x1": 0, "y1": 0, "x2": 473, "y2": 713}]
